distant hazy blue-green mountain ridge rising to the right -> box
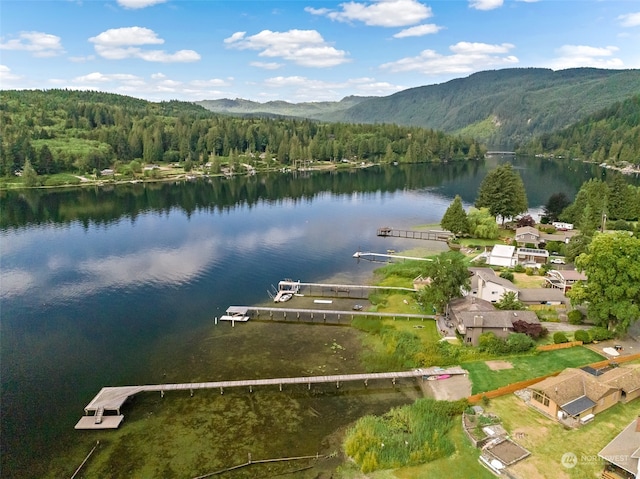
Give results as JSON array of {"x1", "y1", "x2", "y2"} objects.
[{"x1": 196, "y1": 68, "x2": 640, "y2": 148}]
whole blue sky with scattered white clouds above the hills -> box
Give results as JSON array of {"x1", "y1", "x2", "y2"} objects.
[{"x1": 0, "y1": 0, "x2": 640, "y2": 102}]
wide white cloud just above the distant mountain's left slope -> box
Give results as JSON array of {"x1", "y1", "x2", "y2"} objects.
[{"x1": 380, "y1": 42, "x2": 518, "y2": 76}]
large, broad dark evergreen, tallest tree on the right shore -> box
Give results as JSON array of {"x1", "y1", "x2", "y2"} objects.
[{"x1": 476, "y1": 164, "x2": 528, "y2": 224}]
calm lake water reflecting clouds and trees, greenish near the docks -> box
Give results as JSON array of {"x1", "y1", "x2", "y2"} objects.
[{"x1": 0, "y1": 159, "x2": 632, "y2": 477}]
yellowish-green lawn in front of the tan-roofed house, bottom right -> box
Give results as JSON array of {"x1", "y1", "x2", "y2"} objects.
[{"x1": 484, "y1": 394, "x2": 639, "y2": 479}]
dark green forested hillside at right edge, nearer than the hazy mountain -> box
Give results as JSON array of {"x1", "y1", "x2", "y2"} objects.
[{"x1": 522, "y1": 95, "x2": 640, "y2": 171}]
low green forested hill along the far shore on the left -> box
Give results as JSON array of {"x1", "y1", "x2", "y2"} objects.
[{"x1": 0, "y1": 90, "x2": 484, "y2": 182}]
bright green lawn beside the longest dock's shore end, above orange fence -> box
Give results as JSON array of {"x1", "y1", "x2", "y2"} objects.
[{"x1": 462, "y1": 346, "x2": 603, "y2": 394}]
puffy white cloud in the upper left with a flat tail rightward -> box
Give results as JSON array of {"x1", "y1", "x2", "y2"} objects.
[{"x1": 89, "y1": 27, "x2": 200, "y2": 63}]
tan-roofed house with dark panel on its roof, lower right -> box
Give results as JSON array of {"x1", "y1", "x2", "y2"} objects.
[{"x1": 529, "y1": 367, "x2": 640, "y2": 425}]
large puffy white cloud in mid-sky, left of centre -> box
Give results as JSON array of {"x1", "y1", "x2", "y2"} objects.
[{"x1": 224, "y1": 30, "x2": 350, "y2": 68}]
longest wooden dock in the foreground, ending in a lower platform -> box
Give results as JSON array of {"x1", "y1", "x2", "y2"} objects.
[{"x1": 75, "y1": 366, "x2": 467, "y2": 429}]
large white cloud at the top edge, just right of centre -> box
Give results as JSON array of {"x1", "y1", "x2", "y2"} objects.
[{"x1": 305, "y1": 0, "x2": 432, "y2": 27}]
